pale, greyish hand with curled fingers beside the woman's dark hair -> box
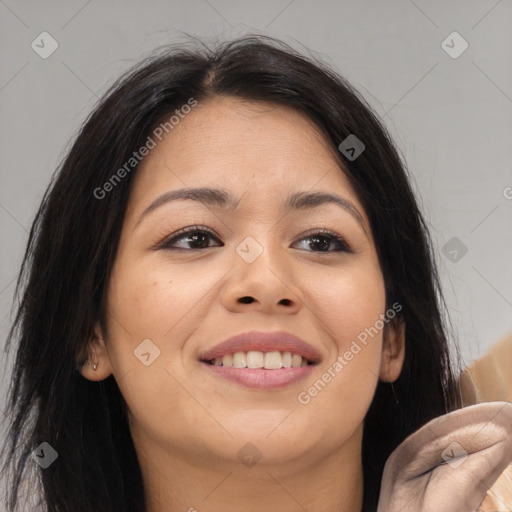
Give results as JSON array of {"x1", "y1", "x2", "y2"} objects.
[{"x1": 377, "y1": 402, "x2": 512, "y2": 512}]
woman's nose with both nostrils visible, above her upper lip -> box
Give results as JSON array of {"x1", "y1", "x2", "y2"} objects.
[{"x1": 222, "y1": 238, "x2": 303, "y2": 314}]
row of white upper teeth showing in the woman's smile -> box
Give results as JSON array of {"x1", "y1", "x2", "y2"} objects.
[{"x1": 203, "y1": 350, "x2": 316, "y2": 370}]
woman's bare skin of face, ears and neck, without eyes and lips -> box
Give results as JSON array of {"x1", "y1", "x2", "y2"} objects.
[{"x1": 82, "y1": 98, "x2": 405, "y2": 512}]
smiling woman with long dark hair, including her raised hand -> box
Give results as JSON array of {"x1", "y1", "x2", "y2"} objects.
[{"x1": 1, "y1": 36, "x2": 512, "y2": 512}]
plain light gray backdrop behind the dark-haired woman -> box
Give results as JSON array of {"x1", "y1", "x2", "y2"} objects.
[{"x1": 0, "y1": 0, "x2": 512, "y2": 420}]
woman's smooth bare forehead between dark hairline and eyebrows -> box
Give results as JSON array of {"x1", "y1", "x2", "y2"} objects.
[{"x1": 125, "y1": 97, "x2": 362, "y2": 218}]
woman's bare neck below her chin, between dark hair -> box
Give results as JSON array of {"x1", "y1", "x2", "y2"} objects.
[{"x1": 135, "y1": 429, "x2": 363, "y2": 512}]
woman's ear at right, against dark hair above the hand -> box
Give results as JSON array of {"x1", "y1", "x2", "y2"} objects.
[{"x1": 380, "y1": 316, "x2": 405, "y2": 382}]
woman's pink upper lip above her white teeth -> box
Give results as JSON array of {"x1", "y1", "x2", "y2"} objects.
[{"x1": 199, "y1": 331, "x2": 321, "y2": 363}]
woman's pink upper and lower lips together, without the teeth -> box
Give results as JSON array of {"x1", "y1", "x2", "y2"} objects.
[{"x1": 199, "y1": 331, "x2": 321, "y2": 390}]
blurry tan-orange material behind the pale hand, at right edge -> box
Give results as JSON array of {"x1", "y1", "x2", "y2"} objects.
[{"x1": 460, "y1": 335, "x2": 512, "y2": 512}]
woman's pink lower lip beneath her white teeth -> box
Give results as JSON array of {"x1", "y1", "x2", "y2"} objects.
[{"x1": 203, "y1": 363, "x2": 315, "y2": 389}]
